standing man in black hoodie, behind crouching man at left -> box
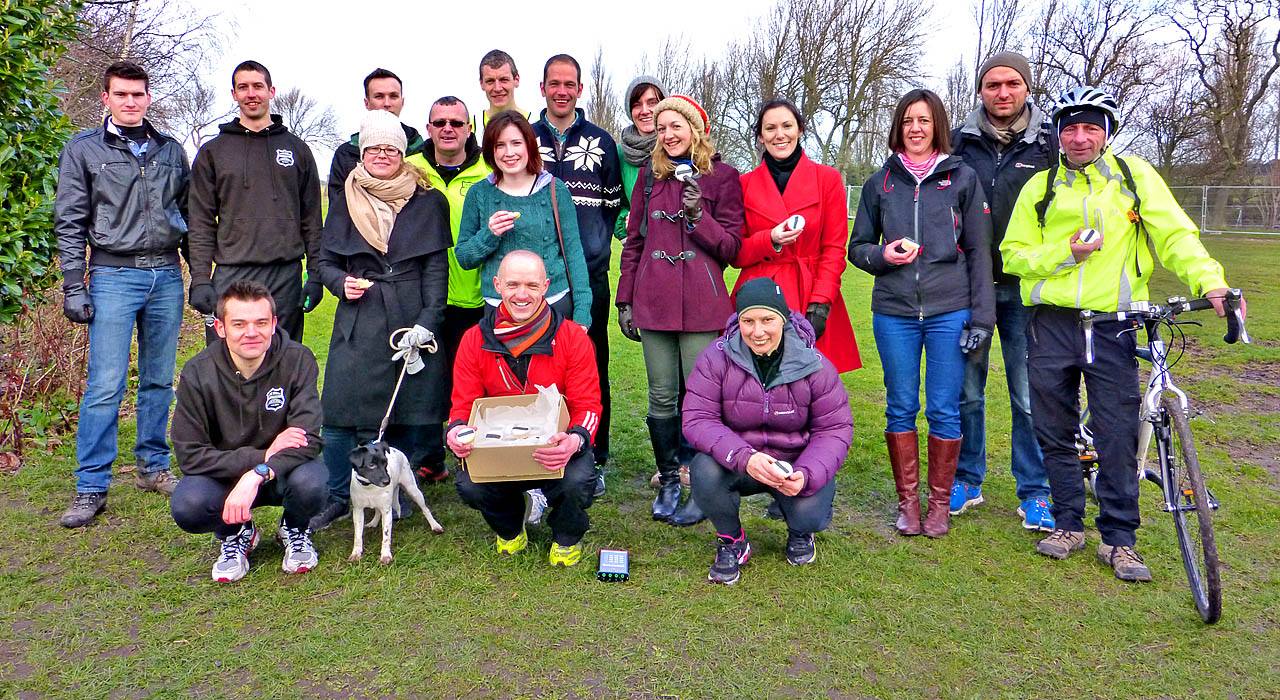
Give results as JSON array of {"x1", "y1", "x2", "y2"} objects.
[{"x1": 188, "y1": 60, "x2": 324, "y2": 343}]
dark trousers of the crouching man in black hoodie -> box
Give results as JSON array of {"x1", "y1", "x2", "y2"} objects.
[{"x1": 169, "y1": 459, "x2": 329, "y2": 537}]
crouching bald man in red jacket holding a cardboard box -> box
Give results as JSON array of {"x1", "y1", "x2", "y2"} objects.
[{"x1": 445, "y1": 251, "x2": 600, "y2": 567}]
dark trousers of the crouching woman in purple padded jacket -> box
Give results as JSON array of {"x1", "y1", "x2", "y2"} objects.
[{"x1": 689, "y1": 452, "x2": 836, "y2": 537}]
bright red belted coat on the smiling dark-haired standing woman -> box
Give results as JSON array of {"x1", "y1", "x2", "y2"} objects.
[{"x1": 733, "y1": 154, "x2": 863, "y2": 372}]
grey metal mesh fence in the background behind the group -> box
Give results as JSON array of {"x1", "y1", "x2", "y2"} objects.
[{"x1": 845, "y1": 184, "x2": 1280, "y2": 235}]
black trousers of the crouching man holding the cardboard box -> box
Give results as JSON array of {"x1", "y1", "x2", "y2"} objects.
[{"x1": 454, "y1": 450, "x2": 595, "y2": 546}]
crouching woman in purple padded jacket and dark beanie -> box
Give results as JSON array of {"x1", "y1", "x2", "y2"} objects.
[{"x1": 684, "y1": 278, "x2": 854, "y2": 584}]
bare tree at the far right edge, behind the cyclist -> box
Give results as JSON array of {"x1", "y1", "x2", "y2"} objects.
[{"x1": 1174, "y1": 0, "x2": 1280, "y2": 183}]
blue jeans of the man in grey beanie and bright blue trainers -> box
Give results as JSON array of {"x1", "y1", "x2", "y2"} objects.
[{"x1": 956, "y1": 284, "x2": 1048, "y2": 500}]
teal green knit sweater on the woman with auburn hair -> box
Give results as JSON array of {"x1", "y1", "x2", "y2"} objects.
[{"x1": 453, "y1": 173, "x2": 591, "y2": 328}]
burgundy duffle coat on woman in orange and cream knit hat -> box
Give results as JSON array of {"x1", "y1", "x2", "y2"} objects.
[{"x1": 614, "y1": 156, "x2": 744, "y2": 333}]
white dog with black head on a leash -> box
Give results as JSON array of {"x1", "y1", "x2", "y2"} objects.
[{"x1": 348, "y1": 441, "x2": 444, "y2": 564}]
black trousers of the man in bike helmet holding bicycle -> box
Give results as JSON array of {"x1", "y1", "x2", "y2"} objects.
[{"x1": 1027, "y1": 306, "x2": 1142, "y2": 546}]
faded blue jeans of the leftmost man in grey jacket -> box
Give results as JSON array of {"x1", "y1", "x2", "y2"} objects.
[{"x1": 76, "y1": 265, "x2": 183, "y2": 493}]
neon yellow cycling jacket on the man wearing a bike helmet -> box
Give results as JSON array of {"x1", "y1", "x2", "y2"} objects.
[{"x1": 1000, "y1": 151, "x2": 1226, "y2": 311}]
